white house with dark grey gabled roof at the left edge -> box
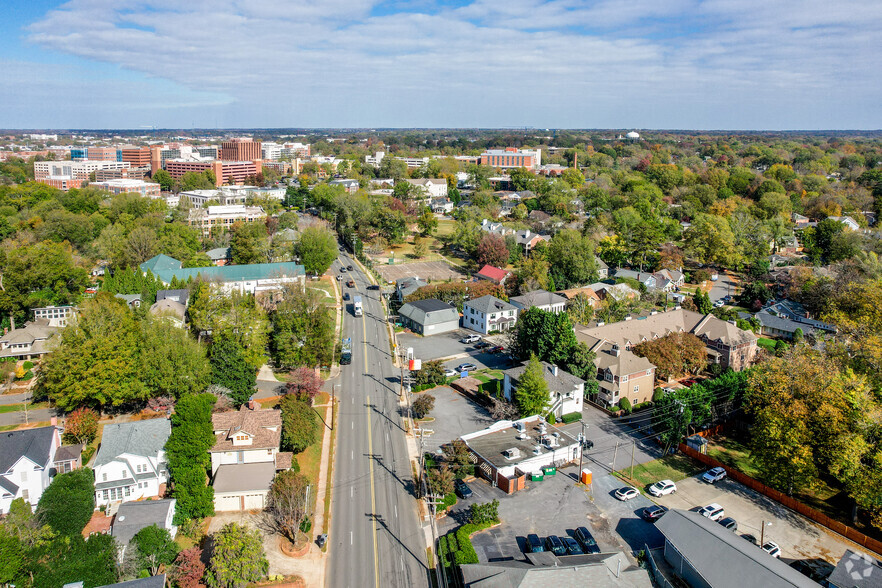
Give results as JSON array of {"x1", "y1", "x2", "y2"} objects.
[{"x1": 0, "y1": 419, "x2": 61, "y2": 515}]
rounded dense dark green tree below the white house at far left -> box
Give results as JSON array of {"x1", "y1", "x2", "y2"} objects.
[{"x1": 37, "y1": 468, "x2": 95, "y2": 536}]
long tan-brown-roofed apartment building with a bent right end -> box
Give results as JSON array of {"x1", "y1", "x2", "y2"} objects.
[{"x1": 576, "y1": 308, "x2": 757, "y2": 371}]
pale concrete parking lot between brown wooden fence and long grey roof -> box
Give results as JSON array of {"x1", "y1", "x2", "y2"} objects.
[{"x1": 657, "y1": 476, "x2": 860, "y2": 565}]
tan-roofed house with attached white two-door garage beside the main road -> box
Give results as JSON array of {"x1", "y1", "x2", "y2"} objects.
[{"x1": 209, "y1": 401, "x2": 291, "y2": 511}]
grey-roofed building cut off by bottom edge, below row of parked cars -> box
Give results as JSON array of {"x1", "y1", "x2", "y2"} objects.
[{"x1": 460, "y1": 551, "x2": 653, "y2": 588}]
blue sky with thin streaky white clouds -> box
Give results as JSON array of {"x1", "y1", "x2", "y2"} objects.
[{"x1": 0, "y1": 0, "x2": 882, "y2": 130}]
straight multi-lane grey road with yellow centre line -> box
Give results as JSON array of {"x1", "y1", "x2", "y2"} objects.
[{"x1": 327, "y1": 254, "x2": 428, "y2": 588}]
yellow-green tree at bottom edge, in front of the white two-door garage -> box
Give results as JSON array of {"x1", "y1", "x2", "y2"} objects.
[{"x1": 205, "y1": 523, "x2": 269, "y2": 588}]
